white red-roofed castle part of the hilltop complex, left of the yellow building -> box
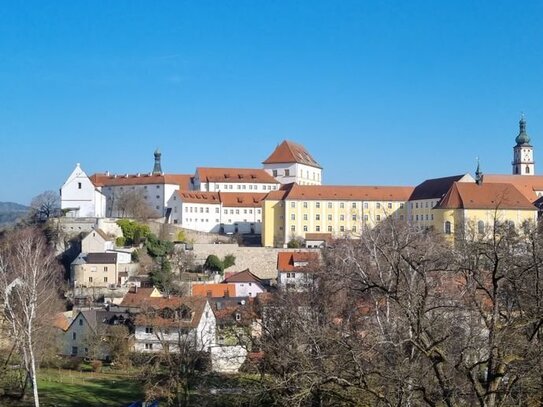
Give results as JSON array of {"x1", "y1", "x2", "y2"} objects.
[{"x1": 60, "y1": 141, "x2": 322, "y2": 234}]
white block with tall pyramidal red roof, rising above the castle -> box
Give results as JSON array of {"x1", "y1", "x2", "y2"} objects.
[{"x1": 262, "y1": 140, "x2": 322, "y2": 185}]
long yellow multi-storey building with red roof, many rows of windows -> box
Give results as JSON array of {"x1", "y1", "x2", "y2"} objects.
[{"x1": 262, "y1": 184, "x2": 413, "y2": 247}]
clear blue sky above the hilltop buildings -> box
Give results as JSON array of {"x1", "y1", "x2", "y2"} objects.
[{"x1": 0, "y1": 0, "x2": 543, "y2": 204}]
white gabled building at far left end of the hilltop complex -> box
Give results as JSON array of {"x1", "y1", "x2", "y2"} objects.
[{"x1": 60, "y1": 163, "x2": 106, "y2": 218}]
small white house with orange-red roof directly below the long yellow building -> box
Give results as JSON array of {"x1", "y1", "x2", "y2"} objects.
[{"x1": 277, "y1": 251, "x2": 319, "y2": 291}]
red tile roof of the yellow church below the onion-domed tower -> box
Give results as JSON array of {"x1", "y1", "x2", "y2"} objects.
[{"x1": 437, "y1": 182, "x2": 536, "y2": 211}]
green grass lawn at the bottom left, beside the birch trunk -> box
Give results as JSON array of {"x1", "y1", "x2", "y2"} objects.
[{"x1": 2, "y1": 369, "x2": 143, "y2": 407}]
